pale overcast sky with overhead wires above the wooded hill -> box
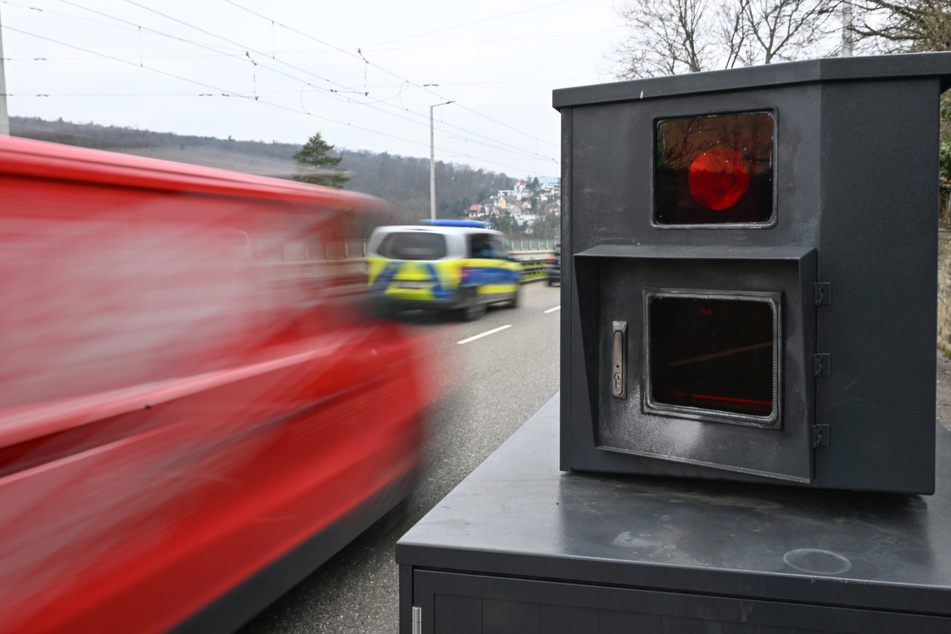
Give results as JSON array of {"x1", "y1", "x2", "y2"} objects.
[{"x1": 0, "y1": 0, "x2": 623, "y2": 177}]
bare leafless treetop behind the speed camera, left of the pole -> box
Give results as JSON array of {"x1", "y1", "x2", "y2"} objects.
[{"x1": 611, "y1": 0, "x2": 840, "y2": 79}]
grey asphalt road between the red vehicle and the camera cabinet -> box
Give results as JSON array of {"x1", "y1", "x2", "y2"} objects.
[{"x1": 241, "y1": 282, "x2": 560, "y2": 634}]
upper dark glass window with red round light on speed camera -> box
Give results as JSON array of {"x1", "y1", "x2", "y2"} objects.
[{"x1": 654, "y1": 112, "x2": 773, "y2": 225}]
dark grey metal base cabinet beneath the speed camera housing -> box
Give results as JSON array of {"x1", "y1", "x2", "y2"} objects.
[{"x1": 396, "y1": 396, "x2": 951, "y2": 634}]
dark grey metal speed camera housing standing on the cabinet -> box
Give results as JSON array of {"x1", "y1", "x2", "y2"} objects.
[{"x1": 554, "y1": 53, "x2": 951, "y2": 494}]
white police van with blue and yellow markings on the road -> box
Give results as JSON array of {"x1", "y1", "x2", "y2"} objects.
[{"x1": 367, "y1": 220, "x2": 523, "y2": 321}]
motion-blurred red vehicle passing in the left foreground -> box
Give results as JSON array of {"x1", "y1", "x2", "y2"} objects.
[{"x1": 0, "y1": 138, "x2": 430, "y2": 632}]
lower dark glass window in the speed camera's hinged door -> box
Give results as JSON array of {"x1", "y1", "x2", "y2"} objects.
[{"x1": 648, "y1": 296, "x2": 776, "y2": 416}]
